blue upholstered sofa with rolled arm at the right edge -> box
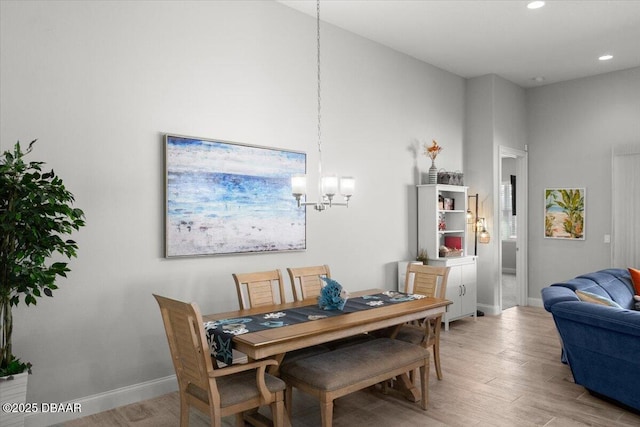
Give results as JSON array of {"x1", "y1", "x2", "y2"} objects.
[{"x1": 542, "y1": 269, "x2": 640, "y2": 411}]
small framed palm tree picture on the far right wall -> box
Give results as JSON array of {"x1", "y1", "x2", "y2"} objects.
[{"x1": 544, "y1": 188, "x2": 586, "y2": 240}]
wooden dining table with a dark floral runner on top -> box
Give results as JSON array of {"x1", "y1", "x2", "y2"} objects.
[{"x1": 203, "y1": 289, "x2": 451, "y2": 425}]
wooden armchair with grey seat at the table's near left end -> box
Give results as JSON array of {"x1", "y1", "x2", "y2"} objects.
[{"x1": 154, "y1": 295, "x2": 286, "y2": 427}]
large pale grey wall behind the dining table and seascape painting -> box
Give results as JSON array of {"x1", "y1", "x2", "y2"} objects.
[{"x1": 0, "y1": 0, "x2": 465, "y2": 422}]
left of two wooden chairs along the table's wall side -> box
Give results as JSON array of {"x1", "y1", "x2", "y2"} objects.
[{"x1": 233, "y1": 270, "x2": 285, "y2": 310}]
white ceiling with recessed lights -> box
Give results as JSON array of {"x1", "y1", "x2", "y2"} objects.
[{"x1": 279, "y1": 0, "x2": 640, "y2": 88}]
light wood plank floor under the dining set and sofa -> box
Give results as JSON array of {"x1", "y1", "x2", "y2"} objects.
[{"x1": 58, "y1": 307, "x2": 640, "y2": 427}]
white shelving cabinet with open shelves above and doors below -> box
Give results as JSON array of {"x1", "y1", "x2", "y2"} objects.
[{"x1": 417, "y1": 184, "x2": 477, "y2": 331}]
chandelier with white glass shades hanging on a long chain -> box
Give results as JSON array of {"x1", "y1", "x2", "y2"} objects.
[{"x1": 291, "y1": 0, "x2": 356, "y2": 212}]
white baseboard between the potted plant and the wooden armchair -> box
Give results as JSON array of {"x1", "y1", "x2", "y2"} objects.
[{"x1": 24, "y1": 375, "x2": 178, "y2": 427}]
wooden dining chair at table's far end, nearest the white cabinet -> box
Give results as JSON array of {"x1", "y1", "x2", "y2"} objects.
[{"x1": 395, "y1": 264, "x2": 450, "y2": 380}]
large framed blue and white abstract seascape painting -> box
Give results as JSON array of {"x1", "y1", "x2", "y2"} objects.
[{"x1": 165, "y1": 135, "x2": 306, "y2": 257}]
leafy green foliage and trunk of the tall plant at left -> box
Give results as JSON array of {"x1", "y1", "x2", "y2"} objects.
[{"x1": 0, "y1": 140, "x2": 84, "y2": 424}]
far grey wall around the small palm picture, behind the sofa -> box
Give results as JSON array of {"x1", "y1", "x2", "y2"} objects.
[{"x1": 526, "y1": 68, "x2": 640, "y2": 298}]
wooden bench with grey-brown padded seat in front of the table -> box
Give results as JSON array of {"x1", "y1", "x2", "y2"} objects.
[{"x1": 280, "y1": 338, "x2": 429, "y2": 427}]
